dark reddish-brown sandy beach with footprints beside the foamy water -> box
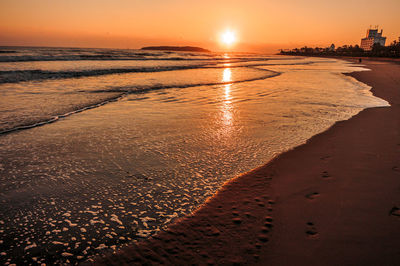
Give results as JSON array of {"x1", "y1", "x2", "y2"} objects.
[{"x1": 96, "y1": 60, "x2": 400, "y2": 265}]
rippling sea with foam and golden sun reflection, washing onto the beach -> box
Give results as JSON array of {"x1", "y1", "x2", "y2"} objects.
[{"x1": 0, "y1": 47, "x2": 388, "y2": 264}]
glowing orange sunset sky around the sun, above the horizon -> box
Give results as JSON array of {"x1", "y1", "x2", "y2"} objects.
[{"x1": 0, "y1": 0, "x2": 400, "y2": 52}]
